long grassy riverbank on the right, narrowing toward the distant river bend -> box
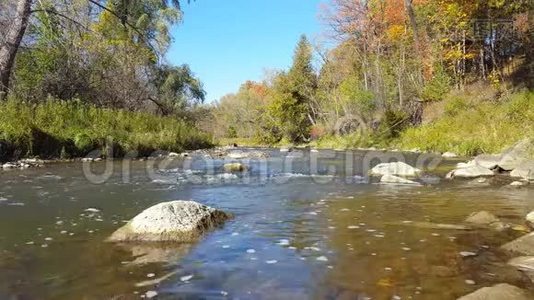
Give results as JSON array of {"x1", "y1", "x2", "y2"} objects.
[{"x1": 220, "y1": 92, "x2": 534, "y2": 156}]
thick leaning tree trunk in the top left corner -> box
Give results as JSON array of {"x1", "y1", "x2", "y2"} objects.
[{"x1": 0, "y1": 0, "x2": 32, "y2": 99}]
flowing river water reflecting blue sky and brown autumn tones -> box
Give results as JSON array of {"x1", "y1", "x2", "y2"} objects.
[{"x1": 0, "y1": 150, "x2": 534, "y2": 299}]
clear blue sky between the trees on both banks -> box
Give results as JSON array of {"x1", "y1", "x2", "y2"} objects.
[{"x1": 167, "y1": 0, "x2": 325, "y2": 101}]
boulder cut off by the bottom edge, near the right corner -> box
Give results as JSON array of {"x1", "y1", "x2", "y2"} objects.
[{"x1": 458, "y1": 283, "x2": 532, "y2": 300}]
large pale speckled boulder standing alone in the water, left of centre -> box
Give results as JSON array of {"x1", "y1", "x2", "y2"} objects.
[{"x1": 108, "y1": 200, "x2": 231, "y2": 242}]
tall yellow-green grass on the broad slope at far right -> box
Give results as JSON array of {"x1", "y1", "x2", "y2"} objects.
[{"x1": 393, "y1": 92, "x2": 534, "y2": 155}]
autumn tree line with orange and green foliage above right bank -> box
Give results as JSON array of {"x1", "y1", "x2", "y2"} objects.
[{"x1": 210, "y1": 0, "x2": 534, "y2": 143}]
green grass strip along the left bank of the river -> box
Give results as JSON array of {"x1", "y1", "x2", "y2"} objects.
[{"x1": 0, "y1": 99, "x2": 212, "y2": 159}]
